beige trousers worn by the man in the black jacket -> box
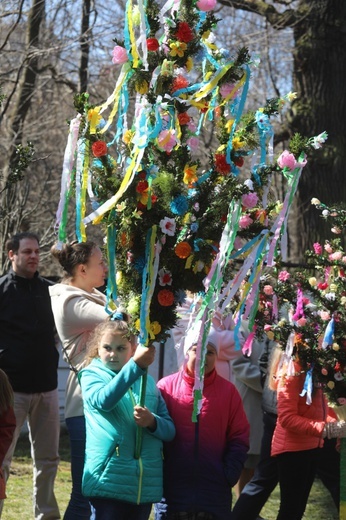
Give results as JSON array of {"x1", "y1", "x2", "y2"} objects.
[{"x1": 0, "y1": 389, "x2": 60, "y2": 520}]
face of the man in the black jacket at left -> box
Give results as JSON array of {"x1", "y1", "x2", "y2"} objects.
[{"x1": 8, "y1": 238, "x2": 40, "y2": 278}]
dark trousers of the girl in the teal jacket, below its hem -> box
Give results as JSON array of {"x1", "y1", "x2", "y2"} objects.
[{"x1": 90, "y1": 498, "x2": 152, "y2": 520}]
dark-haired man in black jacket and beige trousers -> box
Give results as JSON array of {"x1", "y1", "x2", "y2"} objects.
[{"x1": 0, "y1": 232, "x2": 60, "y2": 520}]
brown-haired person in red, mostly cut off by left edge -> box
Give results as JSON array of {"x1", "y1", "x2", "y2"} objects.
[{"x1": 0, "y1": 370, "x2": 16, "y2": 504}]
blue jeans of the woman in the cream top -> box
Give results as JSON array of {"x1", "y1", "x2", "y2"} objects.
[{"x1": 64, "y1": 415, "x2": 93, "y2": 520}]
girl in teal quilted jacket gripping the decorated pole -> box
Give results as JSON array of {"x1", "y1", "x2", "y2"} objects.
[{"x1": 79, "y1": 312, "x2": 175, "y2": 520}]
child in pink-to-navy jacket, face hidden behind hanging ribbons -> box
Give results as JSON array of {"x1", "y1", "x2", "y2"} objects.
[{"x1": 155, "y1": 322, "x2": 249, "y2": 520}]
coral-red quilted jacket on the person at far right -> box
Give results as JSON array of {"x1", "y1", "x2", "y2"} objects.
[{"x1": 271, "y1": 364, "x2": 335, "y2": 456}]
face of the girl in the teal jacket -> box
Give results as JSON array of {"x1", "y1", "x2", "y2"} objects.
[{"x1": 98, "y1": 331, "x2": 135, "y2": 372}]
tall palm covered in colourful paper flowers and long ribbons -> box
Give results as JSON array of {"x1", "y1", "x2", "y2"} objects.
[{"x1": 57, "y1": 0, "x2": 326, "y2": 456}]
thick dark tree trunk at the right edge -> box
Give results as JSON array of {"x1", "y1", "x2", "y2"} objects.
[{"x1": 289, "y1": 0, "x2": 346, "y2": 259}]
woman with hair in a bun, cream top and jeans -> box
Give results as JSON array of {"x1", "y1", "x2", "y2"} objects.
[{"x1": 50, "y1": 241, "x2": 108, "y2": 520}]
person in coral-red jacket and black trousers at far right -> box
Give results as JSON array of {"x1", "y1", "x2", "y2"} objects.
[{"x1": 272, "y1": 354, "x2": 346, "y2": 520}]
